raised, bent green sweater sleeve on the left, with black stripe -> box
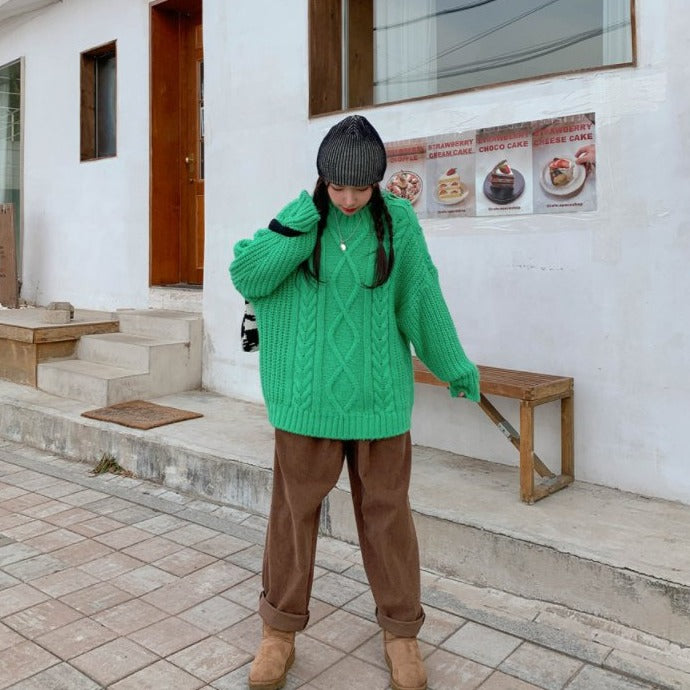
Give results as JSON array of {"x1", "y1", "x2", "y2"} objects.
[{"x1": 230, "y1": 191, "x2": 319, "y2": 300}]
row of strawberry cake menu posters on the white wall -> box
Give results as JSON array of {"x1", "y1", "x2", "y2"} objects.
[{"x1": 384, "y1": 113, "x2": 597, "y2": 218}]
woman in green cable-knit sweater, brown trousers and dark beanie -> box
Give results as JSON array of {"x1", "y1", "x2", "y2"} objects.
[{"x1": 230, "y1": 115, "x2": 479, "y2": 690}]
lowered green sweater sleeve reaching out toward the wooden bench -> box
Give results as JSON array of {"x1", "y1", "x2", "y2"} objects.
[{"x1": 396, "y1": 219, "x2": 479, "y2": 402}]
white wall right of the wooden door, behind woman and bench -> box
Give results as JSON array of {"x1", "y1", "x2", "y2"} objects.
[{"x1": 204, "y1": 0, "x2": 690, "y2": 503}]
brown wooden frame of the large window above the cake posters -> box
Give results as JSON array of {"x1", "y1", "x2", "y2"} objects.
[{"x1": 308, "y1": 0, "x2": 637, "y2": 117}]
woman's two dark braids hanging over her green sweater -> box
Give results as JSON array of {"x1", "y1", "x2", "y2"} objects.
[{"x1": 301, "y1": 177, "x2": 394, "y2": 289}]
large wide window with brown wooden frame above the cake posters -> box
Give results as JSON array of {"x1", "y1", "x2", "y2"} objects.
[{"x1": 309, "y1": 0, "x2": 635, "y2": 115}]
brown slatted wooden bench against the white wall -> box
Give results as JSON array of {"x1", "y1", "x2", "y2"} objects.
[{"x1": 413, "y1": 357, "x2": 575, "y2": 503}]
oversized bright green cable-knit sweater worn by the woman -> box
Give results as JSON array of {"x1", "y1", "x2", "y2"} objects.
[{"x1": 230, "y1": 191, "x2": 479, "y2": 439}]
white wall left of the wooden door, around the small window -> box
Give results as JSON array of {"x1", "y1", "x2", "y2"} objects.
[{"x1": 0, "y1": 0, "x2": 149, "y2": 309}]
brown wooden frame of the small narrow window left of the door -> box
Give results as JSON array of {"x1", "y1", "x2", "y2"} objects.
[{"x1": 79, "y1": 41, "x2": 117, "y2": 162}]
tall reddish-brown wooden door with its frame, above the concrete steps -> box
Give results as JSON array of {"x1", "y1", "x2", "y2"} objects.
[{"x1": 151, "y1": 0, "x2": 204, "y2": 285}]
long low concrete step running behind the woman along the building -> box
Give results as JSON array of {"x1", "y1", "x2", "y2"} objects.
[{"x1": 0, "y1": 382, "x2": 690, "y2": 646}]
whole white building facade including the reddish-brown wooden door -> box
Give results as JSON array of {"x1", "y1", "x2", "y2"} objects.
[{"x1": 0, "y1": 0, "x2": 690, "y2": 503}]
